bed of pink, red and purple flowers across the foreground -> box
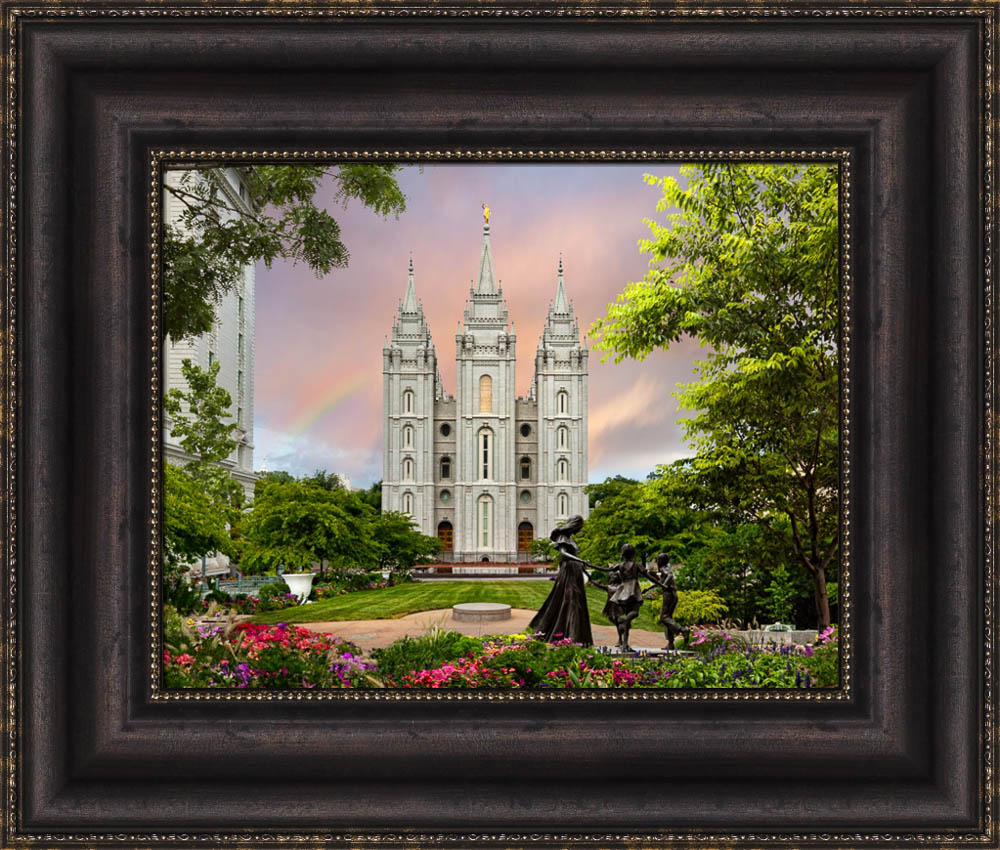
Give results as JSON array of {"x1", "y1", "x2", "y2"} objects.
[{"x1": 163, "y1": 612, "x2": 839, "y2": 689}]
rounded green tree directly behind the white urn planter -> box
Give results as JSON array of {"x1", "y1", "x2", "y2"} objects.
[{"x1": 241, "y1": 480, "x2": 376, "y2": 575}]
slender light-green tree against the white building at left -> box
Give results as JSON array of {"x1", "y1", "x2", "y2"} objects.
[{"x1": 163, "y1": 359, "x2": 243, "y2": 510}]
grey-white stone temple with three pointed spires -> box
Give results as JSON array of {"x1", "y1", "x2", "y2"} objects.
[{"x1": 382, "y1": 217, "x2": 589, "y2": 563}]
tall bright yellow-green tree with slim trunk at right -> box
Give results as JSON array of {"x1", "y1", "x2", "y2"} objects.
[{"x1": 593, "y1": 163, "x2": 839, "y2": 629}]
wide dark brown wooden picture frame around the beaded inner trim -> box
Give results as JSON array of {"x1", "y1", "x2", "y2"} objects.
[{"x1": 0, "y1": 0, "x2": 1000, "y2": 847}]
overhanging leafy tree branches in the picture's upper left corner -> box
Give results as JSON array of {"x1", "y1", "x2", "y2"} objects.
[{"x1": 163, "y1": 163, "x2": 406, "y2": 340}]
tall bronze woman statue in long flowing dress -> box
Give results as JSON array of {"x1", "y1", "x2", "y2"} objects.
[{"x1": 528, "y1": 516, "x2": 594, "y2": 646}]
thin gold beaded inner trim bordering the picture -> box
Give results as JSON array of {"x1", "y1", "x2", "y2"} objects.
[{"x1": 149, "y1": 150, "x2": 853, "y2": 702}]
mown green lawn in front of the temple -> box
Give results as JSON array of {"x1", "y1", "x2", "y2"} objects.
[{"x1": 253, "y1": 581, "x2": 660, "y2": 631}]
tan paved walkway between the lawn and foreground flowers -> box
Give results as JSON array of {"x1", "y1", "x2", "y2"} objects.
[{"x1": 296, "y1": 608, "x2": 666, "y2": 652}]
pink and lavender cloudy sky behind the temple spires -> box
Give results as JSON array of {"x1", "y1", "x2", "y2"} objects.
[{"x1": 254, "y1": 164, "x2": 699, "y2": 486}]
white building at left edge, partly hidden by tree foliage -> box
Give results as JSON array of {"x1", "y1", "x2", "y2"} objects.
[{"x1": 163, "y1": 168, "x2": 255, "y2": 573}]
